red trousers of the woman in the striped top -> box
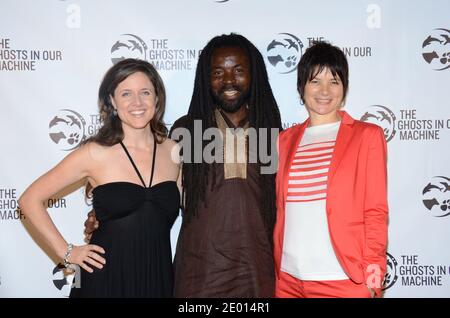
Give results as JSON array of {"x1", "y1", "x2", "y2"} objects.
[{"x1": 275, "y1": 272, "x2": 372, "y2": 298}]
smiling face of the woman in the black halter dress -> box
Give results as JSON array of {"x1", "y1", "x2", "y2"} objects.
[{"x1": 111, "y1": 72, "x2": 158, "y2": 130}]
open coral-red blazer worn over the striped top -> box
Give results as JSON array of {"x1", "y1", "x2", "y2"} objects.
[{"x1": 274, "y1": 111, "x2": 388, "y2": 296}]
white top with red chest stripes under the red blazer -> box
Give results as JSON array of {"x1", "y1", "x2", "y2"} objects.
[{"x1": 281, "y1": 122, "x2": 348, "y2": 281}]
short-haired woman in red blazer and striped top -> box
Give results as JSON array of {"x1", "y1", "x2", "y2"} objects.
[{"x1": 274, "y1": 42, "x2": 388, "y2": 297}]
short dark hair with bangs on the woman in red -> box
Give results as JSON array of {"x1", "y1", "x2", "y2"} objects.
[{"x1": 297, "y1": 42, "x2": 348, "y2": 101}]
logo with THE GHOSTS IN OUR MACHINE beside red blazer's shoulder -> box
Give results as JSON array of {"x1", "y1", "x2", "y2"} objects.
[{"x1": 361, "y1": 105, "x2": 450, "y2": 142}]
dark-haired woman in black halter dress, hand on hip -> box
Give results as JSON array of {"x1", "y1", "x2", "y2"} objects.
[{"x1": 19, "y1": 59, "x2": 180, "y2": 297}]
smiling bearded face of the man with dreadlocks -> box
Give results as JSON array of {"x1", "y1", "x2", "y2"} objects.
[{"x1": 210, "y1": 46, "x2": 251, "y2": 113}]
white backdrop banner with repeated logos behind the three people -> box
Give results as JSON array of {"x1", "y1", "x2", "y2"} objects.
[{"x1": 0, "y1": 0, "x2": 450, "y2": 297}]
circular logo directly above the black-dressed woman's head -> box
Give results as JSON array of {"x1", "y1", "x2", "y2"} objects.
[{"x1": 111, "y1": 34, "x2": 148, "y2": 64}]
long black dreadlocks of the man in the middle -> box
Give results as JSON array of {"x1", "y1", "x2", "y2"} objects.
[{"x1": 172, "y1": 33, "x2": 281, "y2": 236}]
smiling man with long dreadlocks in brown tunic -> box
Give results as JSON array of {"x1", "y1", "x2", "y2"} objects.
[{"x1": 172, "y1": 33, "x2": 281, "y2": 297}]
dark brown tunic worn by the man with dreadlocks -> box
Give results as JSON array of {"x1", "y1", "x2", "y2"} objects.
[{"x1": 174, "y1": 164, "x2": 274, "y2": 297}]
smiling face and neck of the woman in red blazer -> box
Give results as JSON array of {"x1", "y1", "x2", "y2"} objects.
[{"x1": 304, "y1": 67, "x2": 344, "y2": 124}]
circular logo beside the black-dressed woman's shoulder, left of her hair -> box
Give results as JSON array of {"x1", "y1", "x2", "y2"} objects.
[{"x1": 48, "y1": 109, "x2": 86, "y2": 151}]
